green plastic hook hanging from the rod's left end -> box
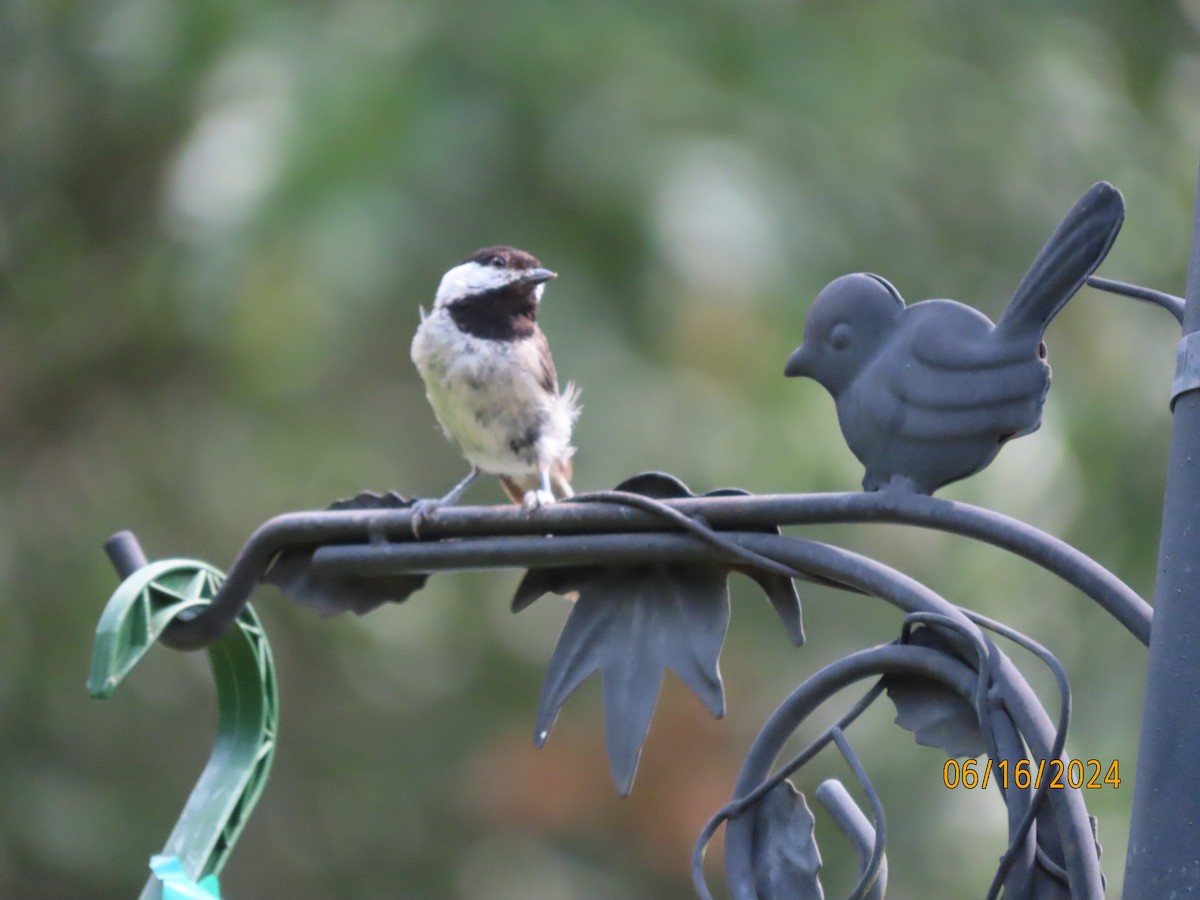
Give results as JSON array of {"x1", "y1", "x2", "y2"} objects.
[{"x1": 88, "y1": 535, "x2": 278, "y2": 900}]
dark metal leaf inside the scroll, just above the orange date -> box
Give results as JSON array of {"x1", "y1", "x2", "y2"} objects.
[{"x1": 883, "y1": 628, "x2": 988, "y2": 757}]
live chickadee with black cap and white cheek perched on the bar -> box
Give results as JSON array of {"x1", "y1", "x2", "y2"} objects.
[{"x1": 412, "y1": 246, "x2": 580, "y2": 527}]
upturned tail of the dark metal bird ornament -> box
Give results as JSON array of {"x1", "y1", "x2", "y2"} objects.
[{"x1": 996, "y1": 181, "x2": 1124, "y2": 341}]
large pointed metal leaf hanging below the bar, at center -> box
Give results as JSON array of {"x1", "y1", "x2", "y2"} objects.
[{"x1": 534, "y1": 565, "x2": 730, "y2": 796}]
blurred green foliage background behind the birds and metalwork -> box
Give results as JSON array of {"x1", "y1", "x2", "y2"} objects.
[{"x1": 0, "y1": 0, "x2": 1200, "y2": 900}]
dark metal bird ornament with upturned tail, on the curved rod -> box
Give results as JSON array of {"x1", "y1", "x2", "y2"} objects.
[{"x1": 784, "y1": 181, "x2": 1124, "y2": 494}]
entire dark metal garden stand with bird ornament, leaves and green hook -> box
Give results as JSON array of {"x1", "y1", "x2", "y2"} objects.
[{"x1": 90, "y1": 172, "x2": 1200, "y2": 900}]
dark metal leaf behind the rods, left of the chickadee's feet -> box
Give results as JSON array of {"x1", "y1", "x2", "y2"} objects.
[{"x1": 263, "y1": 491, "x2": 430, "y2": 616}]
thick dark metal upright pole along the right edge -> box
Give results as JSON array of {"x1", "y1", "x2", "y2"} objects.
[{"x1": 1124, "y1": 165, "x2": 1200, "y2": 900}]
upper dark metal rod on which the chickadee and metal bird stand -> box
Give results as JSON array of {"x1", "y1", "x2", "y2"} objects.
[{"x1": 154, "y1": 493, "x2": 1151, "y2": 649}]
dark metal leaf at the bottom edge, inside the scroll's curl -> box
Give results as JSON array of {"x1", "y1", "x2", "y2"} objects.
[{"x1": 751, "y1": 781, "x2": 824, "y2": 900}]
